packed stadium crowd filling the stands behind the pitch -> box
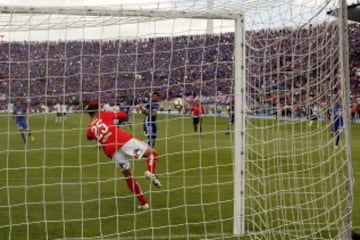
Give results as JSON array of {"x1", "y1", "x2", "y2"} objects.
[{"x1": 0, "y1": 23, "x2": 360, "y2": 117}]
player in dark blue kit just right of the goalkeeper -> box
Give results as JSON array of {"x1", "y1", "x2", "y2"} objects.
[{"x1": 140, "y1": 92, "x2": 160, "y2": 148}]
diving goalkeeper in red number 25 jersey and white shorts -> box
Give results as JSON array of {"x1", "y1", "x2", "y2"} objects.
[{"x1": 83, "y1": 101, "x2": 161, "y2": 210}]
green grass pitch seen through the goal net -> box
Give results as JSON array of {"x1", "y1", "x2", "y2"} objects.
[{"x1": 0, "y1": 114, "x2": 360, "y2": 240}]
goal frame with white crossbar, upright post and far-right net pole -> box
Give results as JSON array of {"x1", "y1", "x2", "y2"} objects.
[{"x1": 0, "y1": 0, "x2": 353, "y2": 239}]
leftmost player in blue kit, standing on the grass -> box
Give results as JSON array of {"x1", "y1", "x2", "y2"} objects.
[{"x1": 13, "y1": 99, "x2": 35, "y2": 143}]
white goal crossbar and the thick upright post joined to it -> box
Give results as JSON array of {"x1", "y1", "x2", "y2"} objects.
[{"x1": 0, "y1": 3, "x2": 246, "y2": 236}]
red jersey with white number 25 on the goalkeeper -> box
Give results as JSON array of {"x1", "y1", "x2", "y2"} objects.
[{"x1": 86, "y1": 112, "x2": 132, "y2": 158}]
